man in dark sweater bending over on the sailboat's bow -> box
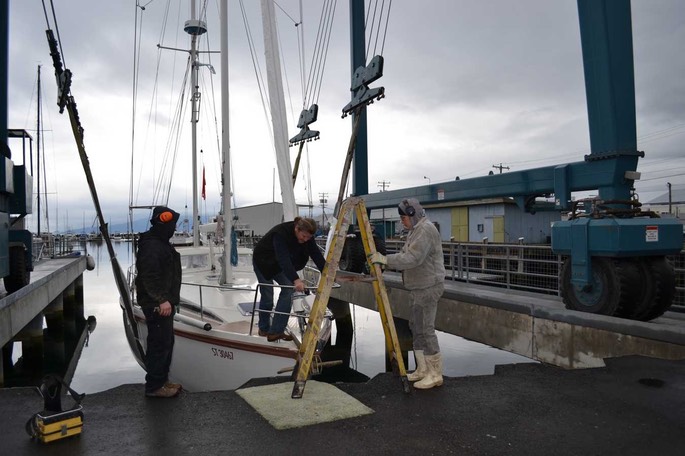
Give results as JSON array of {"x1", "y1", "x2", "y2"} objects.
[{"x1": 252, "y1": 217, "x2": 326, "y2": 342}]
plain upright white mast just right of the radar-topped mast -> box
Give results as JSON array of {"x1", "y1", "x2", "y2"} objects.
[{"x1": 219, "y1": 0, "x2": 233, "y2": 285}]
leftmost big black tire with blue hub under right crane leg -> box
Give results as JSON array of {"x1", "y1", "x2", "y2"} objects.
[{"x1": 561, "y1": 257, "x2": 639, "y2": 315}]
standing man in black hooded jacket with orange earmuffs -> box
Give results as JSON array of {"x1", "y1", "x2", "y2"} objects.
[{"x1": 136, "y1": 206, "x2": 181, "y2": 397}]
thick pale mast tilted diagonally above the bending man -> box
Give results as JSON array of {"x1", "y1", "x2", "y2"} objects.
[{"x1": 262, "y1": 0, "x2": 298, "y2": 221}]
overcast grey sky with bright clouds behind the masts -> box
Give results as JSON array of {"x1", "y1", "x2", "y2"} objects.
[{"x1": 8, "y1": 0, "x2": 685, "y2": 231}]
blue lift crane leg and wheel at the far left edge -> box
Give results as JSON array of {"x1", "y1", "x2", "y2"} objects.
[{"x1": 0, "y1": 0, "x2": 33, "y2": 293}]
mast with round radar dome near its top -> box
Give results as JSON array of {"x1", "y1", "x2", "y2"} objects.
[{"x1": 183, "y1": 0, "x2": 207, "y2": 247}]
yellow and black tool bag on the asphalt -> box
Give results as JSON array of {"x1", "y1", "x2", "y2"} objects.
[{"x1": 26, "y1": 374, "x2": 86, "y2": 443}]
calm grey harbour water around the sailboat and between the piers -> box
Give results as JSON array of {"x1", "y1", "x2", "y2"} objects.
[{"x1": 25, "y1": 242, "x2": 532, "y2": 393}]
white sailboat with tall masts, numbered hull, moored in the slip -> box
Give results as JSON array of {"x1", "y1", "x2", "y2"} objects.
[{"x1": 124, "y1": 0, "x2": 332, "y2": 391}]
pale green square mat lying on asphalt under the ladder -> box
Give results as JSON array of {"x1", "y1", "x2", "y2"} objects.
[{"x1": 236, "y1": 380, "x2": 373, "y2": 429}]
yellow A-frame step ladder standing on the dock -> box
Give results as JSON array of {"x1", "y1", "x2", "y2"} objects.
[{"x1": 291, "y1": 197, "x2": 411, "y2": 399}]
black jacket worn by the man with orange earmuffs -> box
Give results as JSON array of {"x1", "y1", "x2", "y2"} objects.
[{"x1": 136, "y1": 224, "x2": 181, "y2": 308}]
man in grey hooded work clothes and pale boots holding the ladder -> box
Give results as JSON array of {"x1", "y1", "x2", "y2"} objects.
[{"x1": 370, "y1": 198, "x2": 445, "y2": 389}]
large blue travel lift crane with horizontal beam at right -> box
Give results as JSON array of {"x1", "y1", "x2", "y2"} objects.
[{"x1": 344, "y1": 0, "x2": 683, "y2": 321}]
